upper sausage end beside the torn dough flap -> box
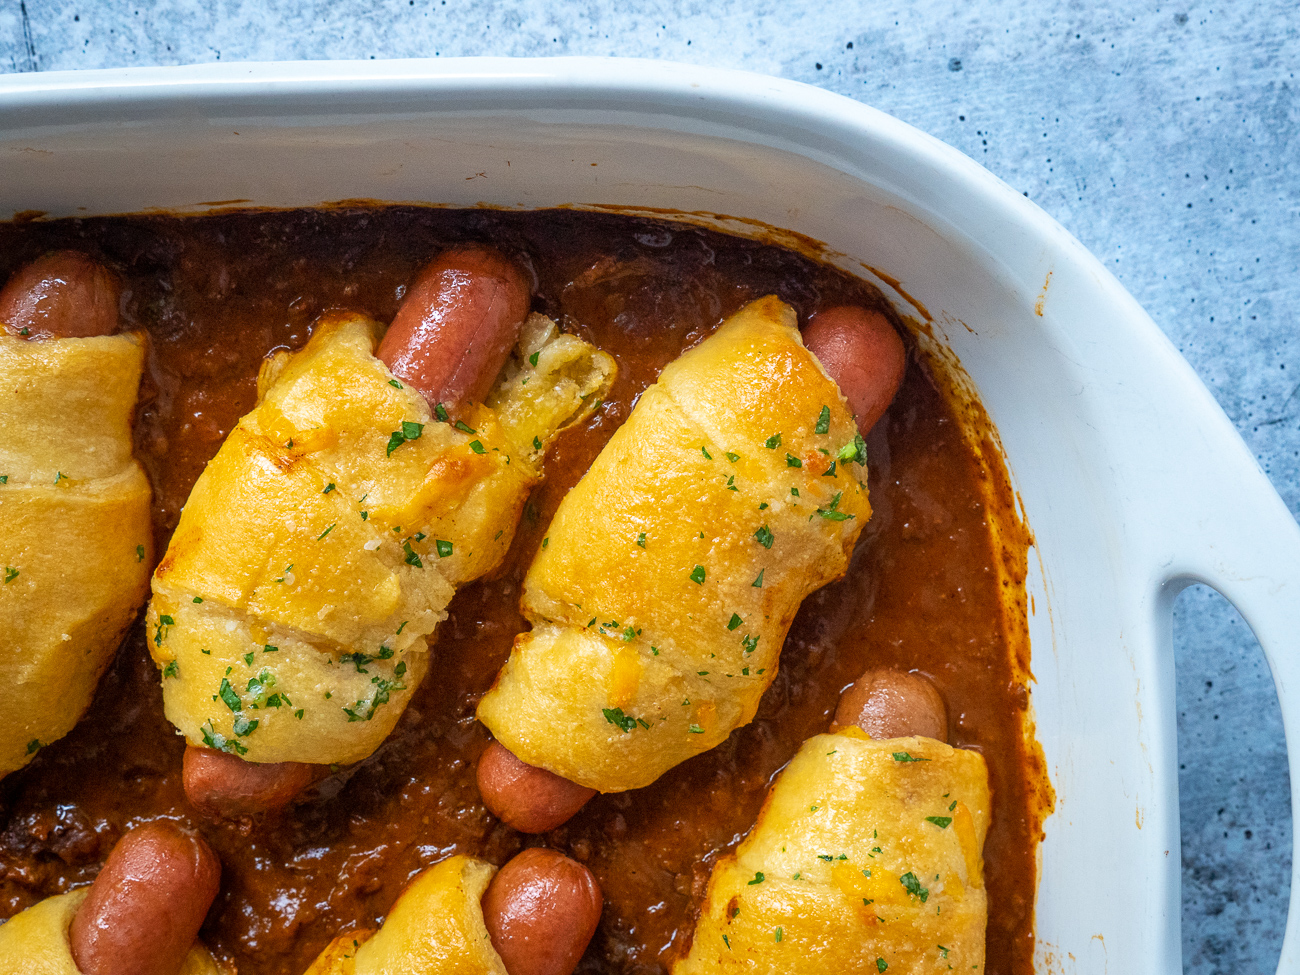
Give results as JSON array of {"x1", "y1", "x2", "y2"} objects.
[{"x1": 376, "y1": 246, "x2": 530, "y2": 410}]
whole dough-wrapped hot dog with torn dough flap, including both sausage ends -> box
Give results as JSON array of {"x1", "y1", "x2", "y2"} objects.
[{"x1": 159, "y1": 246, "x2": 615, "y2": 816}]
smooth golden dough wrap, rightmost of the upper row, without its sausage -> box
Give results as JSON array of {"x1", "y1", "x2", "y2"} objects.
[{"x1": 478, "y1": 296, "x2": 871, "y2": 792}]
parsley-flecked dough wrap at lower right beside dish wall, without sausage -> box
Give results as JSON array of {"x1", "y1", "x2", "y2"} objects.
[{"x1": 673, "y1": 728, "x2": 989, "y2": 975}]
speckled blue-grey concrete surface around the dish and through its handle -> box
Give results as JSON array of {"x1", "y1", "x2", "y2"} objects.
[{"x1": 0, "y1": 0, "x2": 1300, "y2": 975}]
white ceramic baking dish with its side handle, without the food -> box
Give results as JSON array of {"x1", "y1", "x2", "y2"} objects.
[{"x1": 0, "y1": 59, "x2": 1300, "y2": 972}]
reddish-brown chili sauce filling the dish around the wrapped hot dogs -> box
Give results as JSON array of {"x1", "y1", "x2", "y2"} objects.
[{"x1": 0, "y1": 208, "x2": 1045, "y2": 975}]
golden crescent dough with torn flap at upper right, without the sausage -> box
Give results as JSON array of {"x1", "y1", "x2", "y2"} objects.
[{"x1": 148, "y1": 315, "x2": 615, "y2": 764}]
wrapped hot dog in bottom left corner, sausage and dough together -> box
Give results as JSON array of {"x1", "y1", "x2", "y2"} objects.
[{"x1": 0, "y1": 822, "x2": 225, "y2": 975}]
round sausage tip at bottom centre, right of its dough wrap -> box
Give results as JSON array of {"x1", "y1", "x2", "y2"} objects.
[{"x1": 482, "y1": 848, "x2": 605, "y2": 975}]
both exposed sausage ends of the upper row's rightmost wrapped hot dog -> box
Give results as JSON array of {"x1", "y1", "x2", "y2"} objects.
[{"x1": 478, "y1": 303, "x2": 906, "y2": 833}]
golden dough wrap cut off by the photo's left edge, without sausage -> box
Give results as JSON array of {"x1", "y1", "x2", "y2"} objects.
[{"x1": 0, "y1": 335, "x2": 152, "y2": 776}]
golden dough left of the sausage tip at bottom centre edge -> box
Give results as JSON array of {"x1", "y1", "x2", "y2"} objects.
[{"x1": 306, "y1": 857, "x2": 508, "y2": 975}]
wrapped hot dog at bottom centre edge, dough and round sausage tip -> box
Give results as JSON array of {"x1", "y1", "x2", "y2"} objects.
[{"x1": 307, "y1": 849, "x2": 602, "y2": 975}]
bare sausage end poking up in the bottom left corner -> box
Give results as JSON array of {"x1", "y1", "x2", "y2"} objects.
[{"x1": 68, "y1": 822, "x2": 221, "y2": 975}]
